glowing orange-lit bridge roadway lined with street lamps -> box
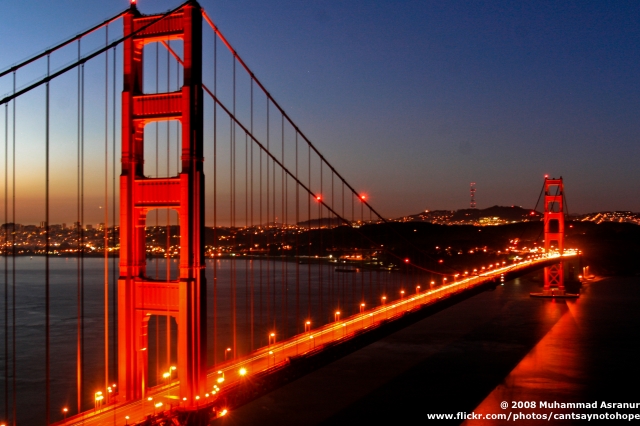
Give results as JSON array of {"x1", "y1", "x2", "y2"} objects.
[{"x1": 55, "y1": 253, "x2": 576, "y2": 425}]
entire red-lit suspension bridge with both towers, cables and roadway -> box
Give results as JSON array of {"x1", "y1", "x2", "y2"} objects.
[{"x1": 0, "y1": 1, "x2": 576, "y2": 424}]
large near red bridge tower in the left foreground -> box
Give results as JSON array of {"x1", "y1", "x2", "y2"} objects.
[{"x1": 118, "y1": 1, "x2": 207, "y2": 405}]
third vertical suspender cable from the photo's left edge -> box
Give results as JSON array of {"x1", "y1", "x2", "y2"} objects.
[{"x1": 44, "y1": 51, "x2": 51, "y2": 424}]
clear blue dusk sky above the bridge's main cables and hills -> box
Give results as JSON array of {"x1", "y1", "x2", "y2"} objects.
[{"x1": 0, "y1": 0, "x2": 640, "y2": 223}]
